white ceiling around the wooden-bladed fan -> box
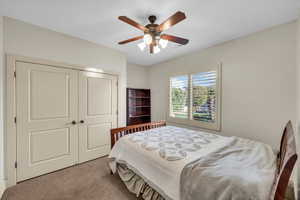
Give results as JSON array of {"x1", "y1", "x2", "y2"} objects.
[{"x1": 0, "y1": 0, "x2": 300, "y2": 65}]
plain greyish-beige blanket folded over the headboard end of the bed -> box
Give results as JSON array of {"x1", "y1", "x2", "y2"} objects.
[{"x1": 180, "y1": 137, "x2": 276, "y2": 200}]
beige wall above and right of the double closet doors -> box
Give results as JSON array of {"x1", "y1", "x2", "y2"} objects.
[{"x1": 0, "y1": 18, "x2": 127, "y2": 187}]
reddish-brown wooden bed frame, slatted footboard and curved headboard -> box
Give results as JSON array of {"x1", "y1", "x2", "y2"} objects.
[{"x1": 111, "y1": 121, "x2": 297, "y2": 200}]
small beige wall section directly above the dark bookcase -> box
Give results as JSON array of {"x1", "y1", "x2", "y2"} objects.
[{"x1": 127, "y1": 63, "x2": 150, "y2": 89}]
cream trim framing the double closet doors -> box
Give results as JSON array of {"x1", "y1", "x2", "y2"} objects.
[{"x1": 5, "y1": 54, "x2": 121, "y2": 187}]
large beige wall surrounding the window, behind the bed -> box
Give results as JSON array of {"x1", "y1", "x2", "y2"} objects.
[{"x1": 150, "y1": 22, "x2": 297, "y2": 149}]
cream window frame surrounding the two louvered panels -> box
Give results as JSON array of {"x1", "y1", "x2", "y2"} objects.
[{"x1": 167, "y1": 64, "x2": 222, "y2": 131}]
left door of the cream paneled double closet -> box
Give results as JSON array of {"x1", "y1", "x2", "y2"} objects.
[{"x1": 16, "y1": 62, "x2": 78, "y2": 181}]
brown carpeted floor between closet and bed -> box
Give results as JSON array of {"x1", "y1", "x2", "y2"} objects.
[{"x1": 1, "y1": 157, "x2": 137, "y2": 200}]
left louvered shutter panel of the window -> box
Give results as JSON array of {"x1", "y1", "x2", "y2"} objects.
[{"x1": 170, "y1": 75, "x2": 189, "y2": 119}]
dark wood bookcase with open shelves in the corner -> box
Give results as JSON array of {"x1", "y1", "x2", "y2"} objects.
[{"x1": 127, "y1": 88, "x2": 151, "y2": 126}]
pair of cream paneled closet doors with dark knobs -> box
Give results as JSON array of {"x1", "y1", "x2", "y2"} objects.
[{"x1": 16, "y1": 62, "x2": 117, "y2": 181}]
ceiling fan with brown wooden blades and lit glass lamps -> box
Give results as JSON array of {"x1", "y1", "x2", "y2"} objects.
[{"x1": 119, "y1": 11, "x2": 189, "y2": 54}]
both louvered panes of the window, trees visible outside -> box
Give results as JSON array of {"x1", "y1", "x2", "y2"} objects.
[{"x1": 170, "y1": 71, "x2": 217, "y2": 123}]
